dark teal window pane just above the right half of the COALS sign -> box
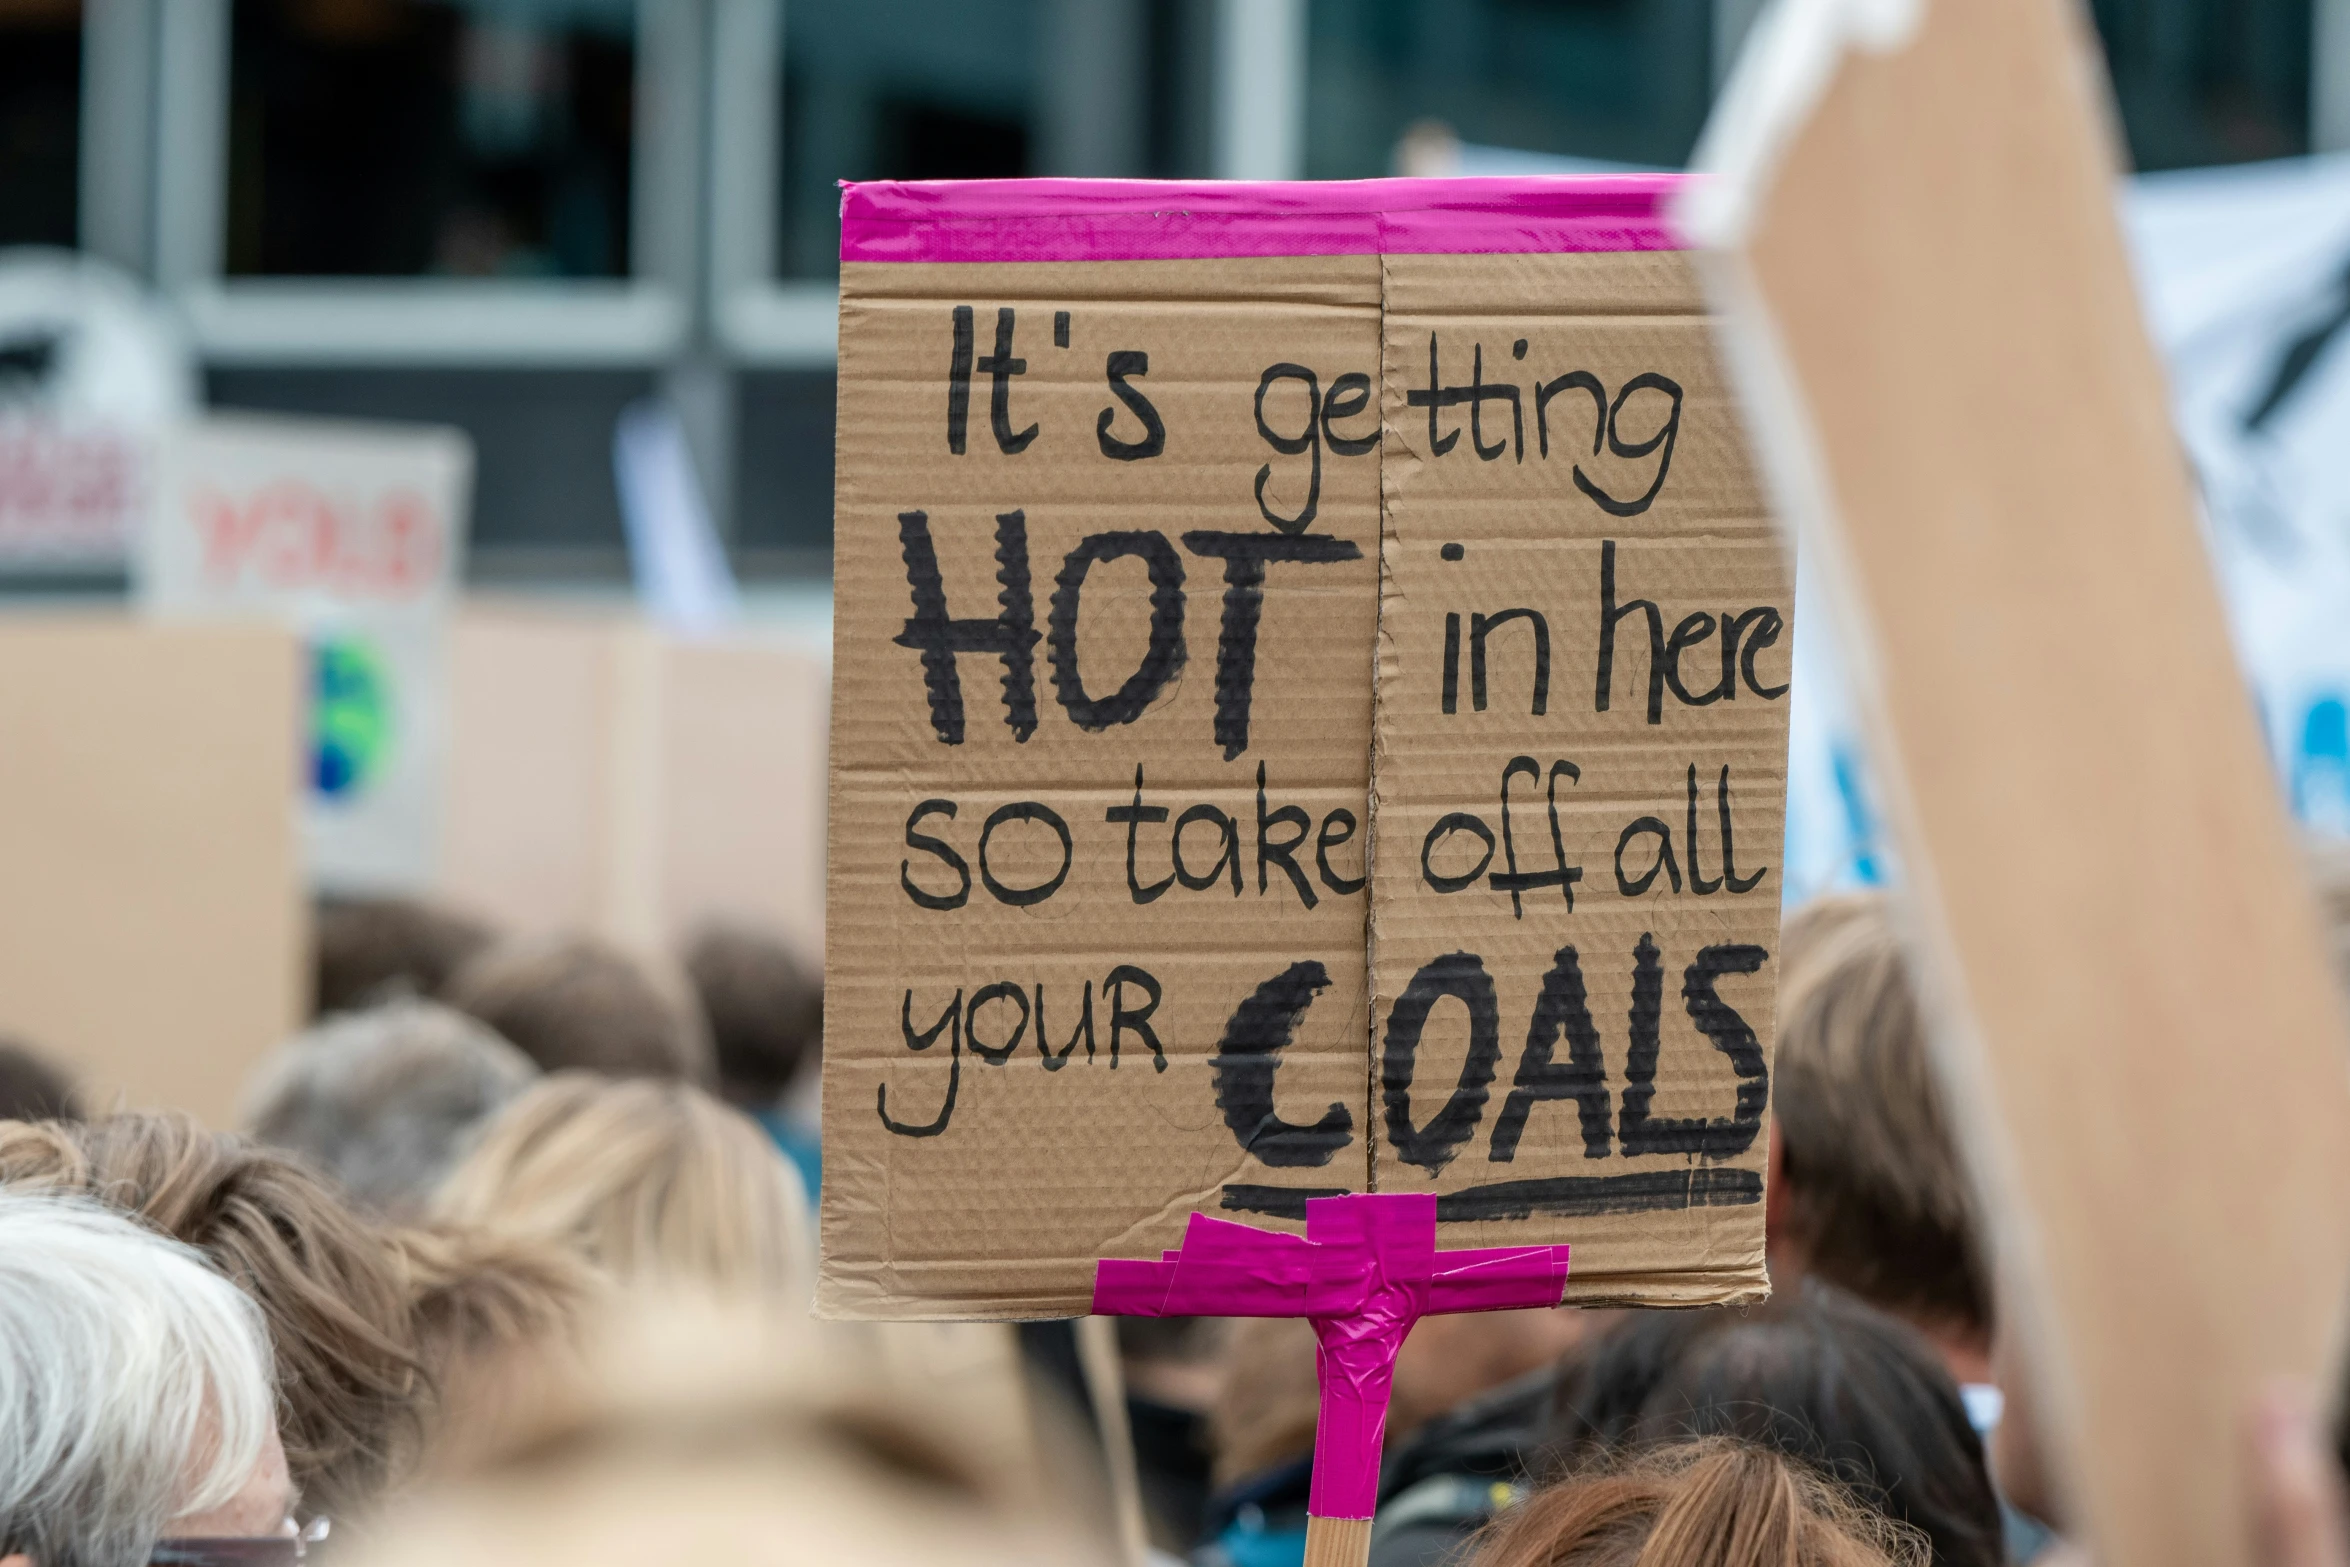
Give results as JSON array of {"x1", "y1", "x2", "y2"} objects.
[{"x1": 1307, "y1": 0, "x2": 1713, "y2": 179}]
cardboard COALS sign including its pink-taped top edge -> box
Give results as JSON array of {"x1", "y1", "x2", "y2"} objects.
[{"x1": 820, "y1": 179, "x2": 1791, "y2": 1316}]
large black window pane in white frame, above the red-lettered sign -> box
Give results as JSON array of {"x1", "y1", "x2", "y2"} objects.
[{"x1": 228, "y1": 0, "x2": 637, "y2": 277}]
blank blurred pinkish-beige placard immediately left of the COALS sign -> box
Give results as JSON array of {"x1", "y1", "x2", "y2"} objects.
[{"x1": 435, "y1": 604, "x2": 830, "y2": 954}]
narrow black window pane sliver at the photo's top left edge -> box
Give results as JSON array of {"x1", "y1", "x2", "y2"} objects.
[{"x1": 0, "y1": 0, "x2": 82, "y2": 244}]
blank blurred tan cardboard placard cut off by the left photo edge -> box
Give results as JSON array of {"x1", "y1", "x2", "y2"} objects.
[{"x1": 0, "y1": 616, "x2": 308, "y2": 1125}]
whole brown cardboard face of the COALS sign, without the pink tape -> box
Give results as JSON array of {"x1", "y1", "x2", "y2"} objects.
[{"x1": 820, "y1": 254, "x2": 1791, "y2": 1318}]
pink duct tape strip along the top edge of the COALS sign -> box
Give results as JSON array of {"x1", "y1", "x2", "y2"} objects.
[{"x1": 841, "y1": 174, "x2": 1687, "y2": 261}]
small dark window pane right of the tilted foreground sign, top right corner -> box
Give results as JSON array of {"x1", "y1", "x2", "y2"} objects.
[{"x1": 2092, "y1": 0, "x2": 2310, "y2": 169}]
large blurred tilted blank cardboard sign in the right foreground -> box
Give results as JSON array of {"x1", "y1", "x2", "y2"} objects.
[{"x1": 1690, "y1": 0, "x2": 2350, "y2": 1565}]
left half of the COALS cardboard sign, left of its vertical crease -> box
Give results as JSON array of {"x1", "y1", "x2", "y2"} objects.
[{"x1": 820, "y1": 256, "x2": 1379, "y2": 1316}]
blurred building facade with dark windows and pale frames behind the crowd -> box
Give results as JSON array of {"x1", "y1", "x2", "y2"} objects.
[{"x1": 0, "y1": 0, "x2": 2350, "y2": 583}]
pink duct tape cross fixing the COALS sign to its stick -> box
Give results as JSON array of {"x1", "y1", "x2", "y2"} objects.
[{"x1": 1093, "y1": 1191, "x2": 1567, "y2": 1518}]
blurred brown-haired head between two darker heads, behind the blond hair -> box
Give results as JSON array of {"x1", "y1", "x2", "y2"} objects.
[{"x1": 444, "y1": 935, "x2": 712, "y2": 1083}]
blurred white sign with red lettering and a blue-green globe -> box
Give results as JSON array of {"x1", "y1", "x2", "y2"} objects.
[{"x1": 136, "y1": 418, "x2": 472, "y2": 890}]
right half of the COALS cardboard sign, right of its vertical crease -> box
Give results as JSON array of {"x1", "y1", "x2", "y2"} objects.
[{"x1": 1372, "y1": 251, "x2": 1793, "y2": 1304}]
